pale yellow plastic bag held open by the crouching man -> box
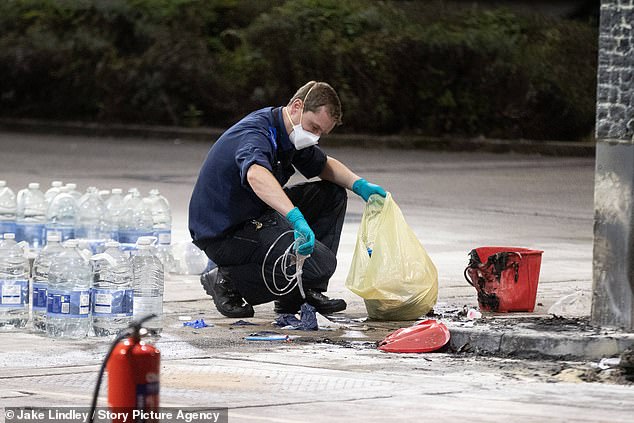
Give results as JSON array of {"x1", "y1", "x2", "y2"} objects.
[{"x1": 346, "y1": 193, "x2": 438, "y2": 320}]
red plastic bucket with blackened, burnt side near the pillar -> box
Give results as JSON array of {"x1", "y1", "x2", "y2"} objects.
[{"x1": 465, "y1": 247, "x2": 543, "y2": 312}]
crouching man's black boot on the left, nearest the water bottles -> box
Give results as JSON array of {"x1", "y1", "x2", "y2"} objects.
[{"x1": 200, "y1": 267, "x2": 254, "y2": 317}]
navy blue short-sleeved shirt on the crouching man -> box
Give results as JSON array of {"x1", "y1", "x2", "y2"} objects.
[{"x1": 189, "y1": 107, "x2": 326, "y2": 249}]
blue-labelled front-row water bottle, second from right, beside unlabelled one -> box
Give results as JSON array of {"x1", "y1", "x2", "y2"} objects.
[{"x1": 91, "y1": 241, "x2": 134, "y2": 336}]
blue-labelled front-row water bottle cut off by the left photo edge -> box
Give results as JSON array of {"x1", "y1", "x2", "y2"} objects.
[{"x1": 0, "y1": 233, "x2": 29, "y2": 330}]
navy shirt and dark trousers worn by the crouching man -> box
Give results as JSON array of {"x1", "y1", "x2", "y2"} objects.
[{"x1": 189, "y1": 107, "x2": 347, "y2": 305}]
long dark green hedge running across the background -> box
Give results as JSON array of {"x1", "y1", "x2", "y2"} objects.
[{"x1": 0, "y1": 0, "x2": 597, "y2": 140}]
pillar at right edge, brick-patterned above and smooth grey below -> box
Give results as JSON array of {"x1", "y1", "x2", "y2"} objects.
[{"x1": 592, "y1": 0, "x2": 634, "y2": 330}]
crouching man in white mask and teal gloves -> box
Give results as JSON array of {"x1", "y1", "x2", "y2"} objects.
[{"x1": 189, "y1": 81, "x2": 386, "y2": 318}]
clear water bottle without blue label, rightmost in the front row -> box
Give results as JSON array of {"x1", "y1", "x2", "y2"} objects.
[{"x1": 132, "y1": 237, "x2": 165, "y2": 335}]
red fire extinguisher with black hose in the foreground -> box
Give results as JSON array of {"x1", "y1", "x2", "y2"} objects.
[{"x1": 91, "y1": 315, "x2": 161, "y2": 423}]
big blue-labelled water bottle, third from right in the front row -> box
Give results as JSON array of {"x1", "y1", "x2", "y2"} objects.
[{"x1": 46, "y1": 239, "x2": 92, "y2": 338}]
